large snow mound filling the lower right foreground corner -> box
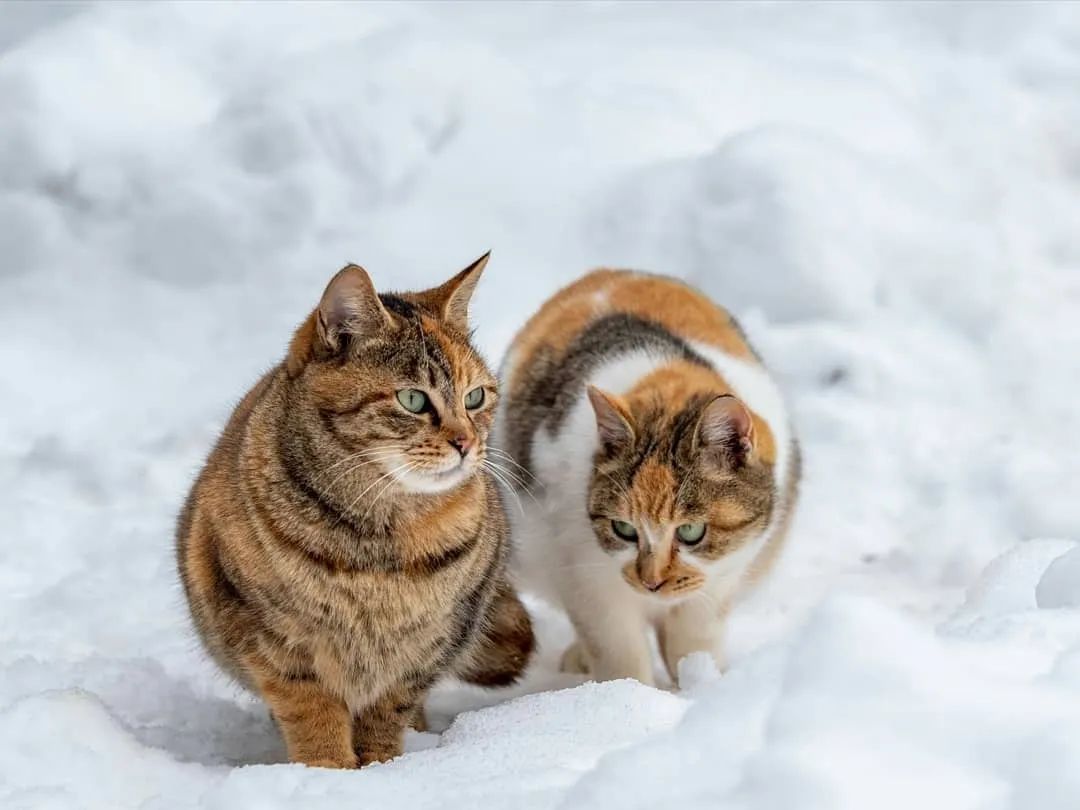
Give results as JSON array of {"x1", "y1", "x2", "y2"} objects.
[{"x1": 566, "y1": 597, "x2": 1080, "y2": 810}]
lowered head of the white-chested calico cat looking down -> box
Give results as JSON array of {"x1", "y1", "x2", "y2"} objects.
[{"x1": 589, "y1": 388, "x2": 775, "y2": 598}]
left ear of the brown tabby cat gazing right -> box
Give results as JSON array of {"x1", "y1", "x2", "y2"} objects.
[{"x1": 285, "y1": 265, "x2": 394, "y2": 377}]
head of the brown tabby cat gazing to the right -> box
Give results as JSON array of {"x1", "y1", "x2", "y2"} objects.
[{"x1": 289, "y1": 257, "x2": 498, "y2": 494}]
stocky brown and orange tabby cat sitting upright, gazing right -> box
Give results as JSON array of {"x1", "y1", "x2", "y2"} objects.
[{"x1": 177, "y1": 256, "x2": 534, "y2": 768}]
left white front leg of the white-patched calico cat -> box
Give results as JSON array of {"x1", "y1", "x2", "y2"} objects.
[{"x1": 563, "y1": 581, "x2": 656, "y2": 686}]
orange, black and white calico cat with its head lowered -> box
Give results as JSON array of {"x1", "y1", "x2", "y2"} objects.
[{"x1": 497, "y1": 270, "x2": 799, "y2": 684}]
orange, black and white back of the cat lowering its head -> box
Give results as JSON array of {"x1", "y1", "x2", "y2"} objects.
[{"x1": 500, "y1": 269, "x2": 786, "y2": 476}]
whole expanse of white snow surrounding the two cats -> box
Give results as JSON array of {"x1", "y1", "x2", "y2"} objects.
[{"x1": 0, "y1": 2, "x2": 1080, "y2": 810}]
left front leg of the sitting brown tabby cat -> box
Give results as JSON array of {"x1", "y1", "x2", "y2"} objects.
[{"x1": 254, "y1": 672, "x2": 356, "y2": 768}]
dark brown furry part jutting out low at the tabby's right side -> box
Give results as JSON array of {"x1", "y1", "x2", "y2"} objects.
[{"x1": 457, "y1": 582, "x2": 536, "y2": 687}]
